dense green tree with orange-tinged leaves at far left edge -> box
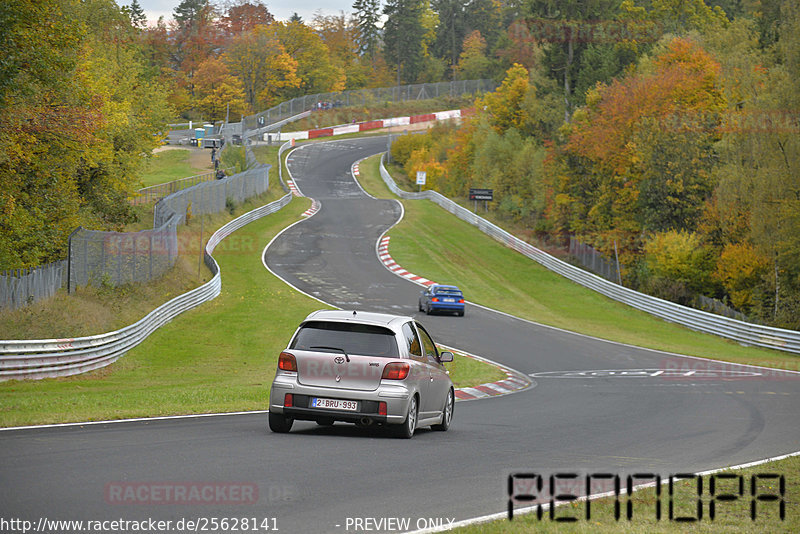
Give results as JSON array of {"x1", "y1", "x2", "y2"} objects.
[{"x1": 0, "y1": 0, "x2": 86, "y2": 270}]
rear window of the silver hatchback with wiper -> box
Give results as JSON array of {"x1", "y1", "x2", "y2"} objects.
[{"x1": 289, "y1": 321, "x2": 399, "y2": 358}]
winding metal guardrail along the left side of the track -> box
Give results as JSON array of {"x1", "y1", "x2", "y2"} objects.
[{"x1": 0, "y1": 194, "x2": 292, "y2": 380}]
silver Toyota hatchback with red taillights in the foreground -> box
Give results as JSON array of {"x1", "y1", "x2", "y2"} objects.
[{"x1": 269, "y1": 310, "x2": 455, "y2": 438}]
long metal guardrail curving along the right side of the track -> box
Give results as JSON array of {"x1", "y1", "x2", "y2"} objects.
[{"x1": 380, "y1": 154, "x2": 800, "y2": 353}]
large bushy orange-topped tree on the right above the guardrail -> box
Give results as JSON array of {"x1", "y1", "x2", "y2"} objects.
[{"x1": 555, "y1": 39, "x2": 726, "y2": 263}]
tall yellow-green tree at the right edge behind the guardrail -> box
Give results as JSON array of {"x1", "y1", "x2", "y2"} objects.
[{"x1": 703, "y1": 1, "x2": 800, "y2": 328}]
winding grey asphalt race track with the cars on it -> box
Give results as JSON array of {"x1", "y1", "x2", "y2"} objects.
[{"x1": 0, "y1": 138, "x2": 800, "y2": 533}]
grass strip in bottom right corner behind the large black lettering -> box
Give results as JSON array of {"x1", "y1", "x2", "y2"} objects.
[{"x1": 453, "y1": 456, "x2": 800, "y2": 534}]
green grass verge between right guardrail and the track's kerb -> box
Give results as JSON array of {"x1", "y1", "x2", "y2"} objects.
[{"x1": 360, "y1": 156, "x2": 800, "y2": 370}]
